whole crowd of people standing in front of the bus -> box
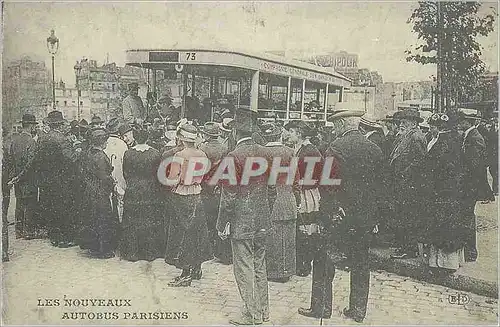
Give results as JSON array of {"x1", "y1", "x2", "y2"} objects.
[{"x1": 2, "y1": 94, "x2": 498, "y2": 324}]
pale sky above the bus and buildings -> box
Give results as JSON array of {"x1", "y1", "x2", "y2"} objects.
[{"x1": 3, "y1": 0, "x2": 498, "y2": 84}]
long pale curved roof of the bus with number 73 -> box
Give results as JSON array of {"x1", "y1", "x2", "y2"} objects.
[{"x1": 126, "y1": 48, "x2": 351, "y2": 87}]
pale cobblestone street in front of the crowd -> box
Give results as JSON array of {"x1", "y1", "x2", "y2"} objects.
[{"x1": 3, "y1": 228, "x2": 498, "y2": 325}]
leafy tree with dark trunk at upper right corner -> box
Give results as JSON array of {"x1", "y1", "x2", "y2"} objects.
[{"x1": 405, "y1": 1, "x2": 496, "y2": 111}]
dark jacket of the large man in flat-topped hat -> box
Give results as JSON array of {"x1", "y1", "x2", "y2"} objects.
[{"x1": 324, "y1": 130, "x2": 383, "y2": 229}]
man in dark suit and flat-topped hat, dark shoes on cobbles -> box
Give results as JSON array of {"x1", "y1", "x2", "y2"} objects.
[{"x1": 298, "y1": 111, "x2": 383, "y2": 322}]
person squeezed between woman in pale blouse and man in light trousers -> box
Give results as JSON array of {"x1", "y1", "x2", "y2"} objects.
[{"x1": 198, "y1": 122, "x2": 232, "y2": 264}]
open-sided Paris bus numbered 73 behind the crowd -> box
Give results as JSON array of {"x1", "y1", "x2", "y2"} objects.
[{"x1": 126, "y1": 49, "x2": 351, "y2": 121}]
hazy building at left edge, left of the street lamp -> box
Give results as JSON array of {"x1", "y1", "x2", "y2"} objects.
[{"x1": 2, "y1": 56, "x2": 52, "y2": 129}]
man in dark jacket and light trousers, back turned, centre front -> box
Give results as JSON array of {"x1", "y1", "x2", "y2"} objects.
[{"x1": 217, "y1": 109, "x2": 271, "y2": 325}]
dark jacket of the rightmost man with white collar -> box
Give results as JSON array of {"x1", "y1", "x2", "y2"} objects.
[{"x1": 460, "y1": 128, "x2": 486, "y2": 200}]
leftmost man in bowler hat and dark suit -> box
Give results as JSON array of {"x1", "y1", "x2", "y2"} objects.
[{"x1": 7, "y1": 114, "x2": 40, "y2": 239}]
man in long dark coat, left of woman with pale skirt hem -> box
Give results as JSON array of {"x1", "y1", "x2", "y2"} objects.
[{"x1": 389, "y1": 109, "x2": 427, "y2": 259}]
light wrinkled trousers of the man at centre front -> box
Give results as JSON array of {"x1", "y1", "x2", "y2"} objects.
[{"x1": 231, "y1": 237, "x2": 269, "y2": 322}]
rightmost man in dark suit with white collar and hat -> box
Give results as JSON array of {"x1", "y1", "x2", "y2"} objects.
[{"x1": 458, "y1": 111, "x2": 486, "y2": 262}]
